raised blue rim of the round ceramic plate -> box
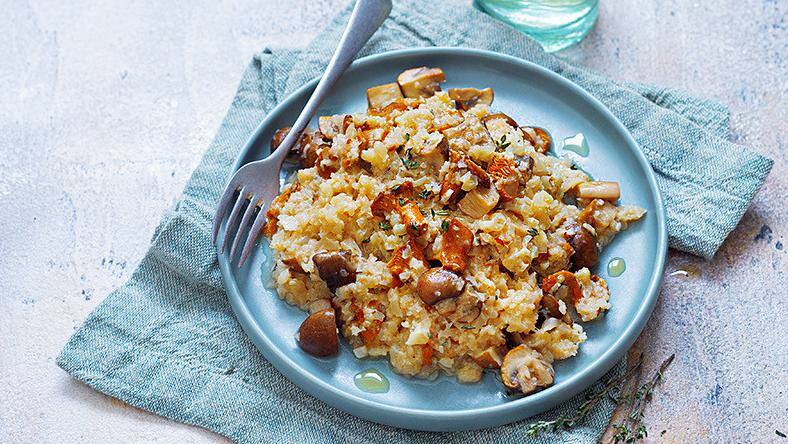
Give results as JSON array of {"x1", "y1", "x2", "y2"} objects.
[{"x1": 217, "y1": 47, "x2": 668, "y2": 431}]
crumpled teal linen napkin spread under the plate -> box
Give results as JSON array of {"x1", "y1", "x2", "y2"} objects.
[{"x1": 57, "y1": 0, "x2": 772, "y2": 444}]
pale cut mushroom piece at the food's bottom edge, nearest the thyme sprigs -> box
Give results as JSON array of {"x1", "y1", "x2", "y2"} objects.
[{"x1": 501, "y1": 344, "x2": 555, "y2": 395}]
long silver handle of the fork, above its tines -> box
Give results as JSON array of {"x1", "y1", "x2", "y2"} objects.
[{"x1": 271, "y1": 0, "x2": 391, "y2": 162}]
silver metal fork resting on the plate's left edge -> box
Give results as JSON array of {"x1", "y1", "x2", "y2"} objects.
[{"x1": 211, "y1": 0, "x2": 391, "y2": 267}]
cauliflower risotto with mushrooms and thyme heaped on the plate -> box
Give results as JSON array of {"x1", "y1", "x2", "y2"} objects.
[{"x1": 264, "y1": 67, "x2": 645, "y2": 394}]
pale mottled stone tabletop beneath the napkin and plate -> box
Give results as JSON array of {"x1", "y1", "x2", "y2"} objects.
[{"x1": 0, "y1": 0, "x2": 788, "y2": 442}]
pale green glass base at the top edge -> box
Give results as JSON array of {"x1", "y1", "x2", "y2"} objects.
[{"x1": 476, "y1": 0, "x2": 599, "y2": 52}]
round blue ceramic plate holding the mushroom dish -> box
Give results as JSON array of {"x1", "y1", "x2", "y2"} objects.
[{"x1": 219, "y1": 48, "x2": 667, "y2": 431}]
